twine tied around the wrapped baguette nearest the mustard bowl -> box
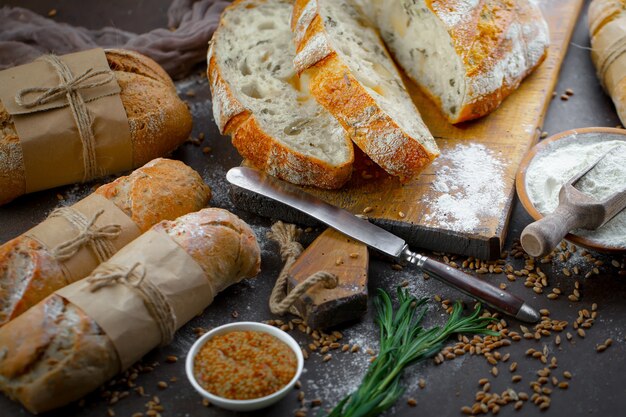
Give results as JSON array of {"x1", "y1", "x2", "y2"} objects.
[{"x1": 87, "y1": 262, "x2": 176, "y2": 346}]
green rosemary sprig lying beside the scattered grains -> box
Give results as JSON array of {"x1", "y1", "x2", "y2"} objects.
[{"x1": 328, "y1": 288, "x2": 499, "y2": 417}]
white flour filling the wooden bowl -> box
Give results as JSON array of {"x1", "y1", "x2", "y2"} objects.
[{"x1": 526, "y1": 134, "x2": 626, "y2": 248}]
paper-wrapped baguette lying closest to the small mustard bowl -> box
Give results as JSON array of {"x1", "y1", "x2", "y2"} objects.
[{"x1": 0, "y1": 208, "x2": 260, "y2": 413}]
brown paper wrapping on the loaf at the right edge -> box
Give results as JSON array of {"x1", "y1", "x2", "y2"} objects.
[{"x1": 591, "y1": 15, "x2": 626, "y2": 123}]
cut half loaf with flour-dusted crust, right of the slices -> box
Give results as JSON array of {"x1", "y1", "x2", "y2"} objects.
[{"x1": 374, "y1": 0, "x2": 549, "y2": 123}]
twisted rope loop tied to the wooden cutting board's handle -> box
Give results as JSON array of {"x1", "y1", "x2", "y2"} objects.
[{"x1": 267, "y1": 221, "x2": 339, "y2": 317}]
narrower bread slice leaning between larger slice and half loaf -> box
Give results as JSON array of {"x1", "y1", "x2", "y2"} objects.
[{"x1": 291, "y1": 0, "x2": 439, "y2": 181}]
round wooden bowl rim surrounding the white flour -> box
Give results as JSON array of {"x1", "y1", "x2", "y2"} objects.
[{"x1": 515, "y1": 127, "x2": 626, "y2": 253}]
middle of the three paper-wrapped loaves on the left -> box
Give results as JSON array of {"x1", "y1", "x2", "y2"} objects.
[{"x1": 0, "y1": 158, "x2": 211, "y2": 327}]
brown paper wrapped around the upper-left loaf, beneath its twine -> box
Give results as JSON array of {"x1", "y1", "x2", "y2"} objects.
[{"x1": 0, "y1": 49, "x2": 132, "y2": 192}]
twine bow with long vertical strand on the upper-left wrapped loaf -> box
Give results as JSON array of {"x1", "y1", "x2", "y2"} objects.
[{"x1": 15, "y1": 55, "x2": 117, "y2": 182}]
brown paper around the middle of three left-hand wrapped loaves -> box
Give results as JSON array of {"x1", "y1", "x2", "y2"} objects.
[{"x1": 25, "y1": 194, "x2": 141, "y2": 284}]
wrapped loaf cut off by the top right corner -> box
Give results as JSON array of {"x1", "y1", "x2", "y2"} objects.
[{"x1": 589, "y1": 0, "x2": 626, "y2": 126}]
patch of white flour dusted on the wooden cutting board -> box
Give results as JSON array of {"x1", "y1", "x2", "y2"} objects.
[{"x1": 424, "y1": 143, "x2": 506, "y2": 232}]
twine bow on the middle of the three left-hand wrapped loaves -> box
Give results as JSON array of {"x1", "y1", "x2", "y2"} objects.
[{"x1": 50, "y1": 207, "x2": 122, "y2": 263}]
